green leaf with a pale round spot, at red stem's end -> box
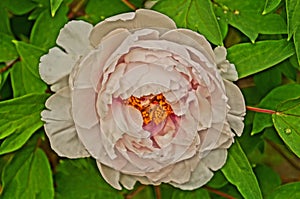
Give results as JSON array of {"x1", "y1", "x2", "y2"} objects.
[{"x1": 272, "y1": 96, "x2": 300, "y2": 157}]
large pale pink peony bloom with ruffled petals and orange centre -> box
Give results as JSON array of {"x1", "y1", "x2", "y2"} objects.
[{"x1": 39, "y1": 9, "x2": 245, "y2": 190}]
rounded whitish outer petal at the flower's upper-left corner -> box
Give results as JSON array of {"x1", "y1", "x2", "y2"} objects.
[{"x1": 56, "y1": 21, "x2": 93, "y2": 56}]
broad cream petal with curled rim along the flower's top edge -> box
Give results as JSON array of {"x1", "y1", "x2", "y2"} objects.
[{"x1": 90, "y1": 9, "x2": 176, "y2": 46}]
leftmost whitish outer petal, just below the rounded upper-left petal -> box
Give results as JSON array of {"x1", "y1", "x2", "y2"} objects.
[{"x1": 39, "y1": 47, "x2": 76, "y2": 84}]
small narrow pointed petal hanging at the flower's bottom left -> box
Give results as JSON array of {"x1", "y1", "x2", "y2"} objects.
[{"x1": 97, "y1": 161, "x2": 122, "y2": 190}]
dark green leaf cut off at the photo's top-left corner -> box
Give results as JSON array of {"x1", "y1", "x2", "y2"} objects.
[{"x1": 2, "y1": 0, "x2": 37, "y2": 15}]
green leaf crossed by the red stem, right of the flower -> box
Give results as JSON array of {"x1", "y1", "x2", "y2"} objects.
[{"x1": 251, "y1": 84, "x2": 300, "y2": 135}]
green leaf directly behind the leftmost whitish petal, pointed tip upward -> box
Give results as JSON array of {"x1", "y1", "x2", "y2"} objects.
[{"x1": 11, "y1": 41, "x2": 47, "y2": 97}]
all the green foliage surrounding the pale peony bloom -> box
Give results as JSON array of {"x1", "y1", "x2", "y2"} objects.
[{"x1": 0, "y1": 0, "x2": 300, "y2": 199}]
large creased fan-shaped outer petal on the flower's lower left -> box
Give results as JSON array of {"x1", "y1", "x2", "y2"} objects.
[{"x1": 41, "y1": 88, "x2": 90, "y2": 158}]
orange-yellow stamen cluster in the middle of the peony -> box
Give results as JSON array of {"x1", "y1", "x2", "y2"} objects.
[{"x1": 126, "y1": 93, "x2": 173, "y2": 126}]
